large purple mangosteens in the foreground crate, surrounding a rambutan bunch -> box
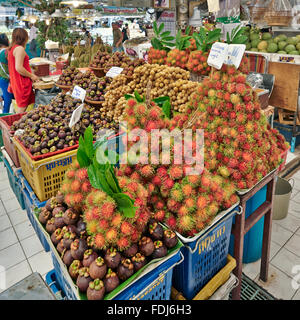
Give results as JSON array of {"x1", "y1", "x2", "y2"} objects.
[{"x1": 38, "y1": 192, "x2": 178, "y2": 300}]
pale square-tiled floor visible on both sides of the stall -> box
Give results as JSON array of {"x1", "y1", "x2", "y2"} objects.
[{"x1": 0, "y1": 156, "x2": 300, "y2": 300}]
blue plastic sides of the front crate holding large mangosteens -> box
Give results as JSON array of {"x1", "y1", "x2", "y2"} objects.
[{"x1": 51, "y1": 250, "x2": 182, "y2": 300}]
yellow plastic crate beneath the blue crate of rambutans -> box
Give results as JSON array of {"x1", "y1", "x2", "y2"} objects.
[{"x1": 171, "y1": 255, "x2": 236, "y2": 300}]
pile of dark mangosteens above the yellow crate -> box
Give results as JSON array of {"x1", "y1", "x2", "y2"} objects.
[{"x1": 10, "y1": 93, "x2": 117, "y2": 156}]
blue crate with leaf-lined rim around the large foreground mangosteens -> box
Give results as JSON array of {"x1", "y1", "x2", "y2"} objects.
[{"x1": 34, "y1": 212, "x2": 183, "y2": 300}]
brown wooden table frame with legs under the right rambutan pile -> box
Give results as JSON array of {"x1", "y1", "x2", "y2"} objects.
[{"x1": 231, "y1": 170, "x2": 277, "y2": 300}]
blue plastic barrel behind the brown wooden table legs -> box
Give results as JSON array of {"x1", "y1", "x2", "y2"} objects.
[{"x1": 229, "y1": 186, "x2": 267, "y2": 263}]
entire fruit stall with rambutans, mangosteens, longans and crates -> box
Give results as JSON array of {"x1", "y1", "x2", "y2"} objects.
[{"x1": 0, "y1": 6, "x2": 291, "y2": 300}]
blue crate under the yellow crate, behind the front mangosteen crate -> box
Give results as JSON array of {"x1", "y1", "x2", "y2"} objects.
[{"x1": 20, "y1": 174, "x2": 50, "y2": 252}]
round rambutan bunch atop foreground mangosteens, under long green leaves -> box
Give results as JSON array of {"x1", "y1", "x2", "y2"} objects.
[{"x1": 83, "y1": 177, "x2": 151, "y2": 251}]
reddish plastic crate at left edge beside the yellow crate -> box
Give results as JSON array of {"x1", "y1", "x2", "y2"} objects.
[{"x1": 0, "y1": 112, "x2": 26, "y2": 168}]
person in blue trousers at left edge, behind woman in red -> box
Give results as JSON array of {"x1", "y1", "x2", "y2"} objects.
[{"x1": 0, "y1": 33, "x2": 13, "y2": 113}]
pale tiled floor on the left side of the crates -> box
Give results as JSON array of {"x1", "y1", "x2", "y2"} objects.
[{"x1": 0, "y1": 162, "x2": 53, "y2": 292}]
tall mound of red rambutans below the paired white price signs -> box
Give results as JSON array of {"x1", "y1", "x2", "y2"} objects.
[{"x1": 190, "y1": 62, "x2": 289, "y2": 190}]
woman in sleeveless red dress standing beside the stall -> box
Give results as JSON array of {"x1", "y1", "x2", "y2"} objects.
[{"x1": 7, "y1": 28, "x2": 39, "y2": 113}]
